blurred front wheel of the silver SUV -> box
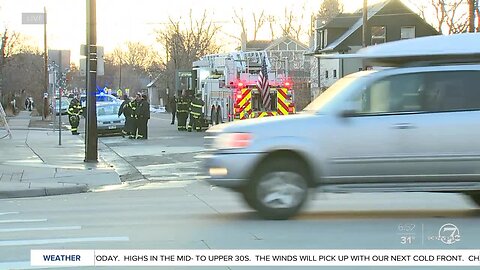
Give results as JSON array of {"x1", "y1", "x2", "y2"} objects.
[{"x1": 244, "y1": 159, "x2": 308, "y2": 219}]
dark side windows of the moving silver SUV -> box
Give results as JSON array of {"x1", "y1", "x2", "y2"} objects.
[{"x1": 353, "y1": 71, "x2": 480, "y2": 115}]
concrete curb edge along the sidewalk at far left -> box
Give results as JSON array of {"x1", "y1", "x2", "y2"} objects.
[{"x1": 0, "y1": 185, "x2": 89, "y2": 199}]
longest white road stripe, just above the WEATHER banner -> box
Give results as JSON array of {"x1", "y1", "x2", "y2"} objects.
[{"x1": 0, "y1": 236, "x2": 130, "y2": 247}]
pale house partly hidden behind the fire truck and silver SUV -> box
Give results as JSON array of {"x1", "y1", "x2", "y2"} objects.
[{"x1": 242, "y1": 36, "x2": 310, "y2": 110}]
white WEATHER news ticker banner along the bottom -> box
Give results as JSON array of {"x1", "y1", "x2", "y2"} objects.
[{"x1": 30, "y1": 249, "x2": 480, "y2": 266}]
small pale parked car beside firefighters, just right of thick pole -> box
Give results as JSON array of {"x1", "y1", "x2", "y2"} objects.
[{"x1": 97, "y1": 103, "x2": 125, "y2": 134}]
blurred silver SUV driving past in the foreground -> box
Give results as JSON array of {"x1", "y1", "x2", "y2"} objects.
[{"x1": 204, "y1": 33, "x2": 480, "y2": 219}]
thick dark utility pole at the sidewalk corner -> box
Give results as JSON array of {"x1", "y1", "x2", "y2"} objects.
[{"x1": 85, "y1": 0, "x2": 98, "y2": 162}]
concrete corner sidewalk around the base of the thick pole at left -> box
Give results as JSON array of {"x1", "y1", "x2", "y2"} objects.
[{"x1": 0, "y1": 111, "x2": 121, "y2": 199}]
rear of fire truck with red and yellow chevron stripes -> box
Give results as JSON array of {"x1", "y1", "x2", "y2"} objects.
[{"x1": 193, "y1": 51, "x2": 295, "y2": 124}]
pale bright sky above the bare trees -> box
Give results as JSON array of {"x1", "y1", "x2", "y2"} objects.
[{"x1": 0, "y1": 0, "x2": 386, "y2": 63}]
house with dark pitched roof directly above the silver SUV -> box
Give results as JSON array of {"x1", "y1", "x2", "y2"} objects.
[{"x1": 309, "y1": 0, "x2": 439, "y2": 98}]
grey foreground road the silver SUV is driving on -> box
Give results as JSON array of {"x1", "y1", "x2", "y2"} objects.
[{"x1": 0, "y1": 180, "x2": 480, "y2": 269}]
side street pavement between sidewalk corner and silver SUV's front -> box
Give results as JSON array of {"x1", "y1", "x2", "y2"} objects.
[{"x1": 99, "y1": 110, "x2": 204, "y2": 182}]
